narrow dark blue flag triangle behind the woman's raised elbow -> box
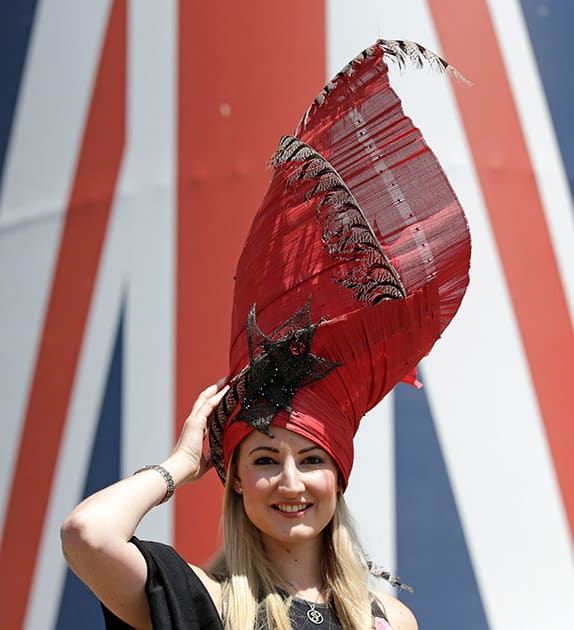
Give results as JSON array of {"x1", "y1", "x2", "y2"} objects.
[{"x1": 56, "y1": 312, "x2": 124, "y2": 630}]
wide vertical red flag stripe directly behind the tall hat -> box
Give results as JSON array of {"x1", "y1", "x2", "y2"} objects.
[{"x1": 175, "y1": 0, "x2": 326, "y2": 564}]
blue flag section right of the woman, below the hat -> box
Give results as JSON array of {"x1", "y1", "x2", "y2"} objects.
[{"x1": 394, "y1": 385, "x2": 488, "y2": 630}]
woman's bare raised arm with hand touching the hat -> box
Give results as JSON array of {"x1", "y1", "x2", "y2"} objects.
[{"x1": 61, "y1": 382, "x2": 226, "y2": 629}]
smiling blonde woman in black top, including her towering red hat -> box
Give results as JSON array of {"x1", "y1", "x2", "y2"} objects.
[{"x1": 62, "y1": 40, "x2": 470, "y2": 630}]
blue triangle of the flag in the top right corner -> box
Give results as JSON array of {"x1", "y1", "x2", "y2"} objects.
[{"x1": 520, "y1": 0, "x2": 574, "y2": 214}]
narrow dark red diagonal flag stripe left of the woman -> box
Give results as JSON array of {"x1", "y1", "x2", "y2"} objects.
[{"x1": 0, "y1": 0, "x2": 126, "y2": 628}]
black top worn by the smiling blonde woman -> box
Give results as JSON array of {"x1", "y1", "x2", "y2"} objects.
[{"x1": 102, "y1": 537, "x2": 390, "y2": 630}]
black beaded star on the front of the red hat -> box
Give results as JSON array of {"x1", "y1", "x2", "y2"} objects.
[{"x1": 232, "y1": 298, "x2": 340, "y2": 436}]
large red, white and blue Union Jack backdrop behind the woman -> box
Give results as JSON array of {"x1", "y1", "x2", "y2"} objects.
[{"x1": 0, "y1": 0, "x2": 574, "y2": 630}]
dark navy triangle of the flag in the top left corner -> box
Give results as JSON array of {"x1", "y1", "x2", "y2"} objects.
[{"x1": 0, "y1": 0, "x2": 37, "y2": 200}]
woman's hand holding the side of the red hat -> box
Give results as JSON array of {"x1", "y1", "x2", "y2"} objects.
[{"x1": 163, "y1": 377, "x2": 229, "y2": 483}]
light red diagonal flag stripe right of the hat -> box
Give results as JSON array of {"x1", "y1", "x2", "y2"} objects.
[{"x1": 429, "y1": 0, "x2": 574, "y2": 534}]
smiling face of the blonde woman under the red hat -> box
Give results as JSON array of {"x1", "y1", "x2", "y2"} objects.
[{"x1": 233, "y1": 426, "x2": 338, "y2": 544}]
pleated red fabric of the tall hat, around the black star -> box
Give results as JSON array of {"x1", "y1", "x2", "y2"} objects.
[{"x1": 210, "y1": 40, "x2": 470, "y2": 483}]
